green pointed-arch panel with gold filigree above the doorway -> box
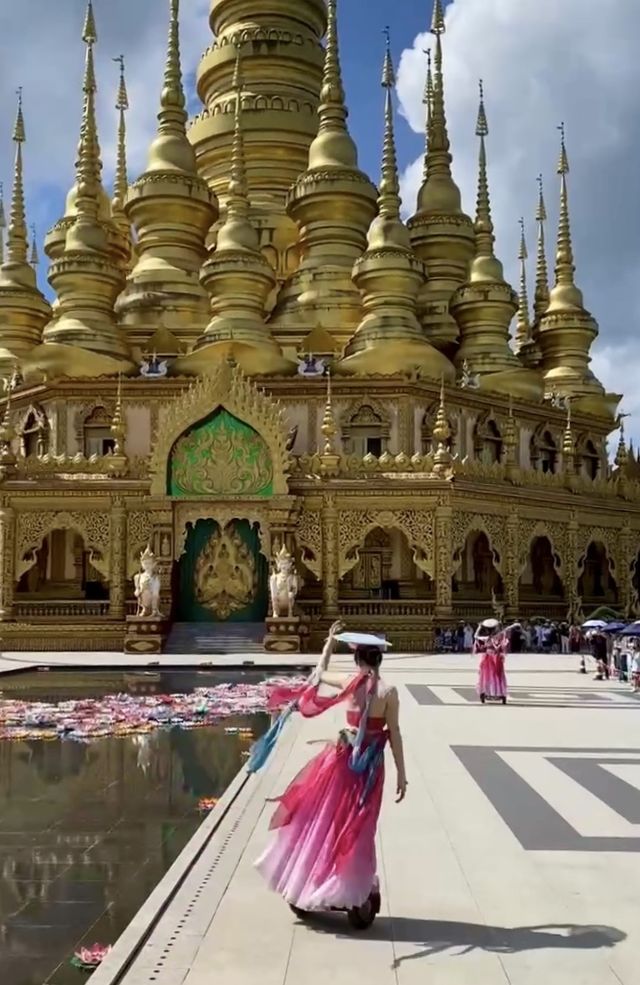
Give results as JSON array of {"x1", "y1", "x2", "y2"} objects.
[{"x1": 167, "y1": 407, "x2": 273, "y2": 497}]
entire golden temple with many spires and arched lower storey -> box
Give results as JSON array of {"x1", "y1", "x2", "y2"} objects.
[{"x1": 0, "y1": 0, "x2": 640, "y2": 650}]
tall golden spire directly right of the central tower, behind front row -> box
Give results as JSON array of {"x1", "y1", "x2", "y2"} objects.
[{"x1": 271, "y1": 0, "x2": 377, "y2": 355}]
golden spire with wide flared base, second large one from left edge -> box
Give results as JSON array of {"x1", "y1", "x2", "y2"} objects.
[{"x1": 33, "y1": 0, "x2": 132, "y2": 377}]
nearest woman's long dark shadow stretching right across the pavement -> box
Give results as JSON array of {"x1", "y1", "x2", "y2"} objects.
[{"x1": 298, "y1": 914, "x2": 627, "y2": 968}]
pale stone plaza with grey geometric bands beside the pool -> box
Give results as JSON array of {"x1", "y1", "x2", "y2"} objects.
[{"x1": 2, "y1": 655, "x2": 640, "y2": 985}]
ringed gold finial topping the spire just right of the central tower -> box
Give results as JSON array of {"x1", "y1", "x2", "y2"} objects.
[{"x1": 309, "y1": 0, "x2": 358, "y2": 168}]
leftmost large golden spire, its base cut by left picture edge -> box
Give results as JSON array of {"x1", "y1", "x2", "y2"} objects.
[{"x1": 0, "y1": 89, "x2": 51, "y2": 377}]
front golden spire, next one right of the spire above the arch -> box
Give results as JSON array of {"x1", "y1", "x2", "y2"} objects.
[{"x1": 340, "y1": 28, "x2": 455, "y2": 379}]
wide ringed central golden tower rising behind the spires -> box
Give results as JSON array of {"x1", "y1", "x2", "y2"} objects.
[{"x1": 190, "y1": 0, "x2": 327, "y2": 281}]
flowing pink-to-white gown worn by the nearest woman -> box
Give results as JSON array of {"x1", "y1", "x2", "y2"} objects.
[{"x1": 256, "y1": 681, "x2": 387, "y2": 912}]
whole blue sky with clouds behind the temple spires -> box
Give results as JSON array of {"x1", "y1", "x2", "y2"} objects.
[{"x1": 0, "y1": 0, "x2": 640, "y2": 438}]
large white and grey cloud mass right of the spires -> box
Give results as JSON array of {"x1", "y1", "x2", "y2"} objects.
[{"x1": 398, "y1": 0, "x2": 640, "y2": 437}]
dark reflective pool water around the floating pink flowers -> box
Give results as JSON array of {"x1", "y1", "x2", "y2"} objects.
[{"x1": 0, "y1": 674, "x2": 268, "y2": 985}]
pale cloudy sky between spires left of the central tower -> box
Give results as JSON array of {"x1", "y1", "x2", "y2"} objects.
[{"x1": 0, "y1": 0, "x2": 212, "y2": 233}]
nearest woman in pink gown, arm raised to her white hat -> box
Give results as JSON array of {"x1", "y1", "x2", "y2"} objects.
[{"x1": 249, "y1": 623, "x2": 407, "y2": 928}]
